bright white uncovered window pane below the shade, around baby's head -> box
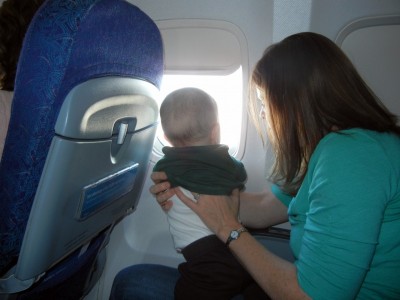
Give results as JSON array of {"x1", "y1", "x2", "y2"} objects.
[{"x1": 155, "y1": 67, "x2": 243, "y2": 155}]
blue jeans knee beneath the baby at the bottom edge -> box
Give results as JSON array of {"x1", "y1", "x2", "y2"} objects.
[{"x1": 110, "y1": 264, "x2": 180, "y2": 300}]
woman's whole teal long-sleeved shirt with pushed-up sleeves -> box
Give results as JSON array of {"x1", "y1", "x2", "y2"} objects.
[{"x1": 272, "y1": 129, "x2": 400, "y2": 299}]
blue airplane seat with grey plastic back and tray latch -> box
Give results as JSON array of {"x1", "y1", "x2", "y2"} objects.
[{"x1": 0, "y1": 0, "x2": 163, "y2": 299}]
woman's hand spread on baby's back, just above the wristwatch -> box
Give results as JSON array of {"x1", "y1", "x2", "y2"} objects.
[{"x1": 174, "y1": 187, "x2": 241, "y2": 242}]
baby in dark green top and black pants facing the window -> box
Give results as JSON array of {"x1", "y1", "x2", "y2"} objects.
[{"x1": 153, "y1": 88, "x2": 252, "y2": 299}]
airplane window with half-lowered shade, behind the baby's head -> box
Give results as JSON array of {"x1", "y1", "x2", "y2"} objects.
[{"x1": 153, "y1": 19, "x2": 248, "y2": 160}]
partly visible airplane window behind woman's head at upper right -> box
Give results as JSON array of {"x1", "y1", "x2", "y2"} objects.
[{"x1": 336, "y1": 16, "x2": 400, "y2": 123}]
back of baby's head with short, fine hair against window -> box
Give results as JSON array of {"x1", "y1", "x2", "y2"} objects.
[{"x1": 160, "y1": 88, "x2": 220, "y2": 147}]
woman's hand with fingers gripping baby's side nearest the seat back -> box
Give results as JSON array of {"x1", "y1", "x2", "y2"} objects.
[{"x1": 150, "y1": 172, "x2": 175, "y2": 211}]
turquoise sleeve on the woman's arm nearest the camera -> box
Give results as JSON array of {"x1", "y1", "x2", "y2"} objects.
[{"x1": 296, "y1": 133, "x2": 390, "y2": 299}]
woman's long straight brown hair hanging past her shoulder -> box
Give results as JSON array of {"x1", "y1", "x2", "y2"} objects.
[{"x1": 250, "y1": 32, "x2": 400, "y2": 195}]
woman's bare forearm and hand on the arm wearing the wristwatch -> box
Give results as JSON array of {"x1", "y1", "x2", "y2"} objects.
[{"x1": 175, "y1": 188, "x2": 309, "y2": 299}]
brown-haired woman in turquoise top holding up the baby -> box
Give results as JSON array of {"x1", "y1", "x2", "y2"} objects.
[{"x1": 110, "y1": 33, "x2": 400, "y2": 299}]
